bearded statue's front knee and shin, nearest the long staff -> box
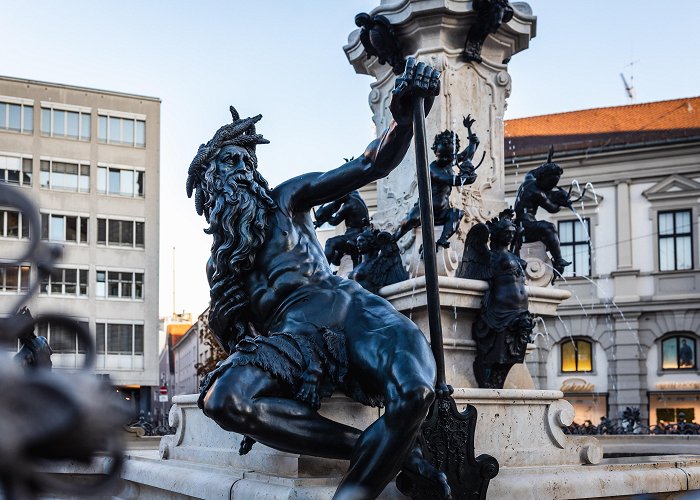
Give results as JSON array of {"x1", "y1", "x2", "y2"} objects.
[{"x1": 334, "y1": 350, "x2": 435, "y2": 500}]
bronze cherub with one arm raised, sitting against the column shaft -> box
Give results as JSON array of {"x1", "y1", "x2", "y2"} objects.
[{"x1": 394, "y1": 116, "x2": 479, "y2": 248}]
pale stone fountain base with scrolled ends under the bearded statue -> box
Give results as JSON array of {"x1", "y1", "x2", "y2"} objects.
[{"x1": 91, "y1": 389, "x2": 700, "y2": 500}]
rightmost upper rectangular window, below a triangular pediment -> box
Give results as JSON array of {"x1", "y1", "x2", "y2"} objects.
[{"x1": 659, "y1": 210, "x2": 693, "y2": 271}]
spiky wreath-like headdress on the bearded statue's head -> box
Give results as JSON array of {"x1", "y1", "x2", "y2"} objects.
[{"x1": 187, "y1": 106, "x2": 270, "y2": 221}]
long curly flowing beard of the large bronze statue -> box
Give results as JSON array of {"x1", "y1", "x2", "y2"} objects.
[{"x1": 205, "y1": 162, "x2": 275, "y2": 353}]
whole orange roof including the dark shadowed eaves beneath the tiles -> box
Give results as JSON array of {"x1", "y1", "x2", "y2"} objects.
[{"x1": 505, "y1": 97, "x2": 700, "y2": 157}]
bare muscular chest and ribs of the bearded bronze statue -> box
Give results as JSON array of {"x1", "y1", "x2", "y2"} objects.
[{"x1": 244, "y1": 184, "x2": 334, "y2": 333}]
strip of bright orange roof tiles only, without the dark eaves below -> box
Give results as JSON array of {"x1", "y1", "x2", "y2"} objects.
[{"x1": 506, "y1": 97, "x2": 700, "y2": 137}]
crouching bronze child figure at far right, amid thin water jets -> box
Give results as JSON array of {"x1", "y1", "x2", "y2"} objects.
[{"x1": 515, "y1": 149, "x2": 583, "y2": 278}]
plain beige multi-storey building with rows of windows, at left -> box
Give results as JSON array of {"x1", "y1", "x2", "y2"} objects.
[{"x1": 0, "y1": 77, "x2": 160, "y2": 413}]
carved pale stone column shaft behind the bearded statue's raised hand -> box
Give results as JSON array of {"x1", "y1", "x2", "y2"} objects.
[{"x1": 344, "y1": 0, "x2": 536, "y2": 274}]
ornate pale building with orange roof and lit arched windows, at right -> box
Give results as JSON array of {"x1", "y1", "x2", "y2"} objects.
[{"x1": 505, "y1": 98, "x2": 700, "y2": 425}]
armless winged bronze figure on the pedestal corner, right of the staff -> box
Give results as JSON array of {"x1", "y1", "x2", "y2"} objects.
[{"x1": 457, "y1": 210, "x2": 534, "y2": 389}]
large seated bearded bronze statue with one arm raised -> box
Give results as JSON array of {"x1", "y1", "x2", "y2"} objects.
[{"x1": 187, "y1": 59, "x2": 449, "y2": 499}]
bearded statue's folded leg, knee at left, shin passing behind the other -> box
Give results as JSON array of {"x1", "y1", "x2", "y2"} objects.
[{"x1": 204, "y1": 365, "x2": 360, "y2": 460}]
